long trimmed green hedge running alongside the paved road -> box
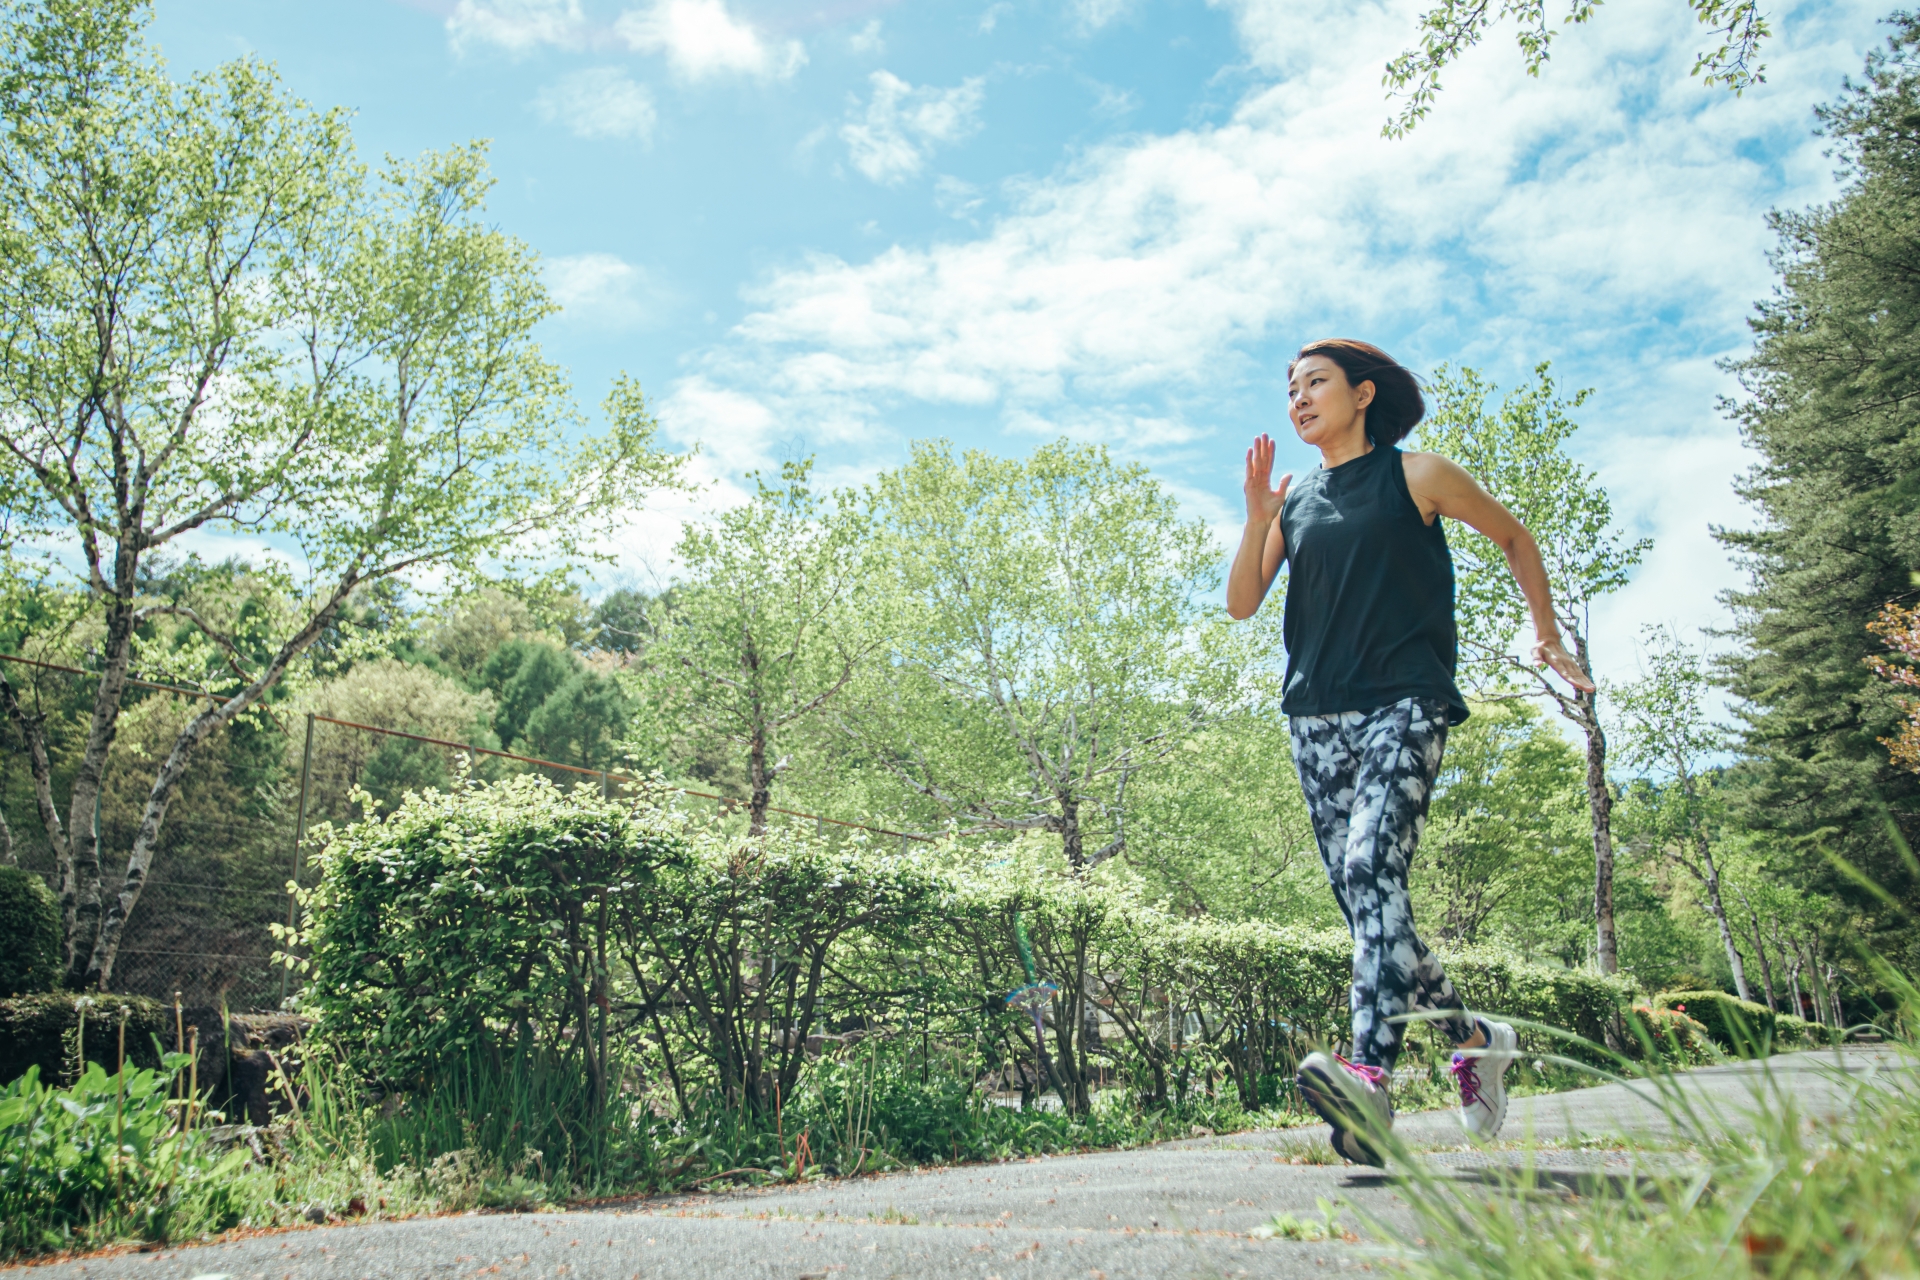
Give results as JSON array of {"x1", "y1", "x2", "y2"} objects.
[{"x1": 301, "y1": 777, "x2": 1630, "y2": 1115}]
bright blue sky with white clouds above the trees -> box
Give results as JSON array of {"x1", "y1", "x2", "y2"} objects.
[{"x1": 154, "y1": 0, "x2": 1882, "y2": 676}]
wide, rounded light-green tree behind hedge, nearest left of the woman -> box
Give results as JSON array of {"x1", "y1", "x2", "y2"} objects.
[{"x1": 845, "y1": 441, "x2": 1271, "y2": 871}]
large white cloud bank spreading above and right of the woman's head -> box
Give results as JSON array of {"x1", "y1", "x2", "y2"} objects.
[{"x1": 656, "y1": 0, "x2": 1878, "y2": 672}]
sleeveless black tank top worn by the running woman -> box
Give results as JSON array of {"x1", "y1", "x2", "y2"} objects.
[{"x1": 1281, "y1": 445, "x2": 1467, "y2": 723}]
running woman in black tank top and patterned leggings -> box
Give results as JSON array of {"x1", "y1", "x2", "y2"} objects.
[{"x1": 1227, "y1": 338, "x2": 1594, "y2": 1165}]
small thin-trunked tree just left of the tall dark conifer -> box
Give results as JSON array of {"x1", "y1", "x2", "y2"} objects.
[{"x1": 1619, "y1": 628, "x2": 1753, "y2": 1000}]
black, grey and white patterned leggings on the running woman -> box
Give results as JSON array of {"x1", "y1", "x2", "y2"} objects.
[{"x1": 1288, "y1": 699, "x2": 1475, "y2": 1071}]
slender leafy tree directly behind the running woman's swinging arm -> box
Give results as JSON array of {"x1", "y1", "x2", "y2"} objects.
[{"x1": 1419, "y1": 365, "x2": 1653, "y2": 973}]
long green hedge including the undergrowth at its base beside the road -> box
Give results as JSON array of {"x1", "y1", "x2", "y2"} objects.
[{"x1": 288, "y1": 777, "x2": 1651, "y2": 1194}]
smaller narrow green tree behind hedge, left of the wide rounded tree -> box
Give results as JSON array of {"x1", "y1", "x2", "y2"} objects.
[{"x1": 630, "y1": 459, "x2": 874, "y2": 835}]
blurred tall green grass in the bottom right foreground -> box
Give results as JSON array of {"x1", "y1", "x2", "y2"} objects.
[{"x1": 1382, "y1": 973, "x2": 1920, "y2": 1280}]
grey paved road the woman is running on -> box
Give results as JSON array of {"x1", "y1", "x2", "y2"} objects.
[{"x1": 33, "y1": 1048, "x2": 1895, "y2": 1280}]
